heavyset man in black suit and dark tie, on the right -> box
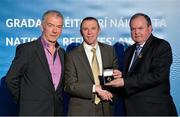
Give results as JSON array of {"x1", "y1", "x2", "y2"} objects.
[{"x1": 107, "y1": 13, "x2": 177, "y2": 116}]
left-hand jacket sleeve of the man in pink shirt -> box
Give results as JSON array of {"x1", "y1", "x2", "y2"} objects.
[{"x1": 5, "y1": 45, "x2": 27, "y2": 103}]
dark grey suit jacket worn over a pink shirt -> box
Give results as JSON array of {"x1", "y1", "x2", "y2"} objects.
[{"x1": 6, "y1": 38, "x2": 64, "y2": 115}]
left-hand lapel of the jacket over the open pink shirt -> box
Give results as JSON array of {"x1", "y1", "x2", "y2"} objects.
[{"x1": 36, "y1": 38, "x2": 52, "y2": 82}]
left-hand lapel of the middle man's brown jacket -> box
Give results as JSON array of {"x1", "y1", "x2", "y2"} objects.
[{"x1": 78, "y1": 44, "x2": 94, "y2": 82}]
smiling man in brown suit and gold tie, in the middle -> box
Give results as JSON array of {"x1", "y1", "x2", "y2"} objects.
[{"x1": 65, "y1": 17, "x2": 121, "y2": 116}]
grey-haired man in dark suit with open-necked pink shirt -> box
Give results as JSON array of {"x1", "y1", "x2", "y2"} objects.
[{"x1": 6, "y1": 10, "x2": 64, "y2": 116}]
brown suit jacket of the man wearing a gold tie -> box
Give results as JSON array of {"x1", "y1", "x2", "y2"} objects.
[{"x1": 65, "y1": 43, "x2": 118, "y2": 116}]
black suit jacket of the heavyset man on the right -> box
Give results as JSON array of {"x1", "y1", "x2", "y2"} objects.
[{"x1": 124, "y1": 35, "x2": 177, "y2": 115}]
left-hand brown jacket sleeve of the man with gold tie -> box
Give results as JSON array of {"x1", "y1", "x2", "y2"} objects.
[{"x1": 64, "y1": 54, "x2": 93, "y2": 99}]
